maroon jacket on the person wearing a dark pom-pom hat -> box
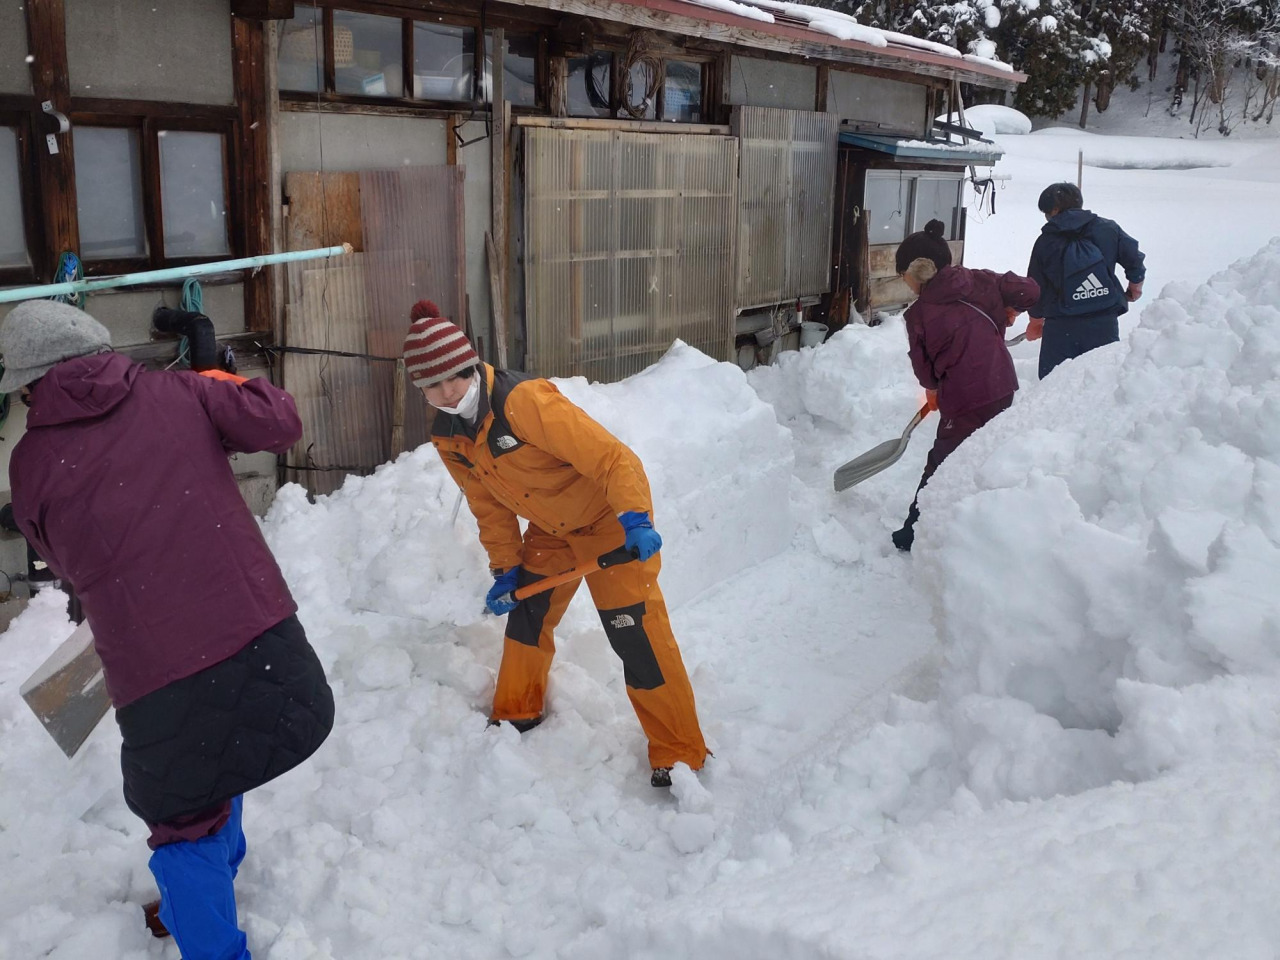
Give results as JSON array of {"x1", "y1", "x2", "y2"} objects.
[{"x1": 906, "y1": 265, "x2": 1039, "y2": 417}]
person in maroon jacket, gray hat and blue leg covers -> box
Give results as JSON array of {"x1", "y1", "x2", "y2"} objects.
[{"x1": 0, "y1": 301, "x2": 333, "y2": 960}]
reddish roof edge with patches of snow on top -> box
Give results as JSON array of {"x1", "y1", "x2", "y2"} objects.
[{"x1": 512, "y1": 0, "x2": 1025, "y2": 88}]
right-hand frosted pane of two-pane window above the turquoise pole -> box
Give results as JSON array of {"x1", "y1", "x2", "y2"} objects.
[{"x1": 160, "y1": 131, "x2": 230, "y2": 257}]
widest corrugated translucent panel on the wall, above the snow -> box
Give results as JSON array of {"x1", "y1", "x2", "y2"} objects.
[{"x1": 525, "y1": 128, "x2": 737, "y2": 381}]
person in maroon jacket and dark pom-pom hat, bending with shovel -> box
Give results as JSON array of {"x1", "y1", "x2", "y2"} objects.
[{"x1": 893, "y1": 220, "x2": 1039, "y2": 550}]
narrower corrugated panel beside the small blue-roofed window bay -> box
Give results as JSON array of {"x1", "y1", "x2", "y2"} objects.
[{"x1": 733, "y1": 106, "x2": 840, "y2": 310}]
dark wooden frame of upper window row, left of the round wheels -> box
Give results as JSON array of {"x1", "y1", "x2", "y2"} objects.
[{"x1": 282, "y1": 0, "x2": 548, "y2": 114}]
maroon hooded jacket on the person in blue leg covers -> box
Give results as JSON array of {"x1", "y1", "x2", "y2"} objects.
[{"x1": 9, "y1": 353, "x2": 302, "y2": 708}]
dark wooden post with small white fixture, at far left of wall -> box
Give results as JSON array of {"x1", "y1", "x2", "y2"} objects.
[{"x1": 26, "y1": 0, "x2": 79, "y2": 278}]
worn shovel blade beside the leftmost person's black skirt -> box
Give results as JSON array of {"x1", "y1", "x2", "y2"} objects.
[{"x1": 18, "y1": 622, "x2": 111, "y2": 756}]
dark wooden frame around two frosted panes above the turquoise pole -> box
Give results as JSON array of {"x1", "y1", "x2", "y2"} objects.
[{"x1": 72, "y1": 111, "x2": 244, "y2": 276}]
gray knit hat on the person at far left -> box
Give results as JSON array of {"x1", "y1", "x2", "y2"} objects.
[{"x1": 0, "y1": 300, "x2": 111, "y2": 393}]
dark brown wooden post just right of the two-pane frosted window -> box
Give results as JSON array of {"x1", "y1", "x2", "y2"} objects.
[{"x1": 232, "y1": 17, "x2": 275, "y2": 332}]
